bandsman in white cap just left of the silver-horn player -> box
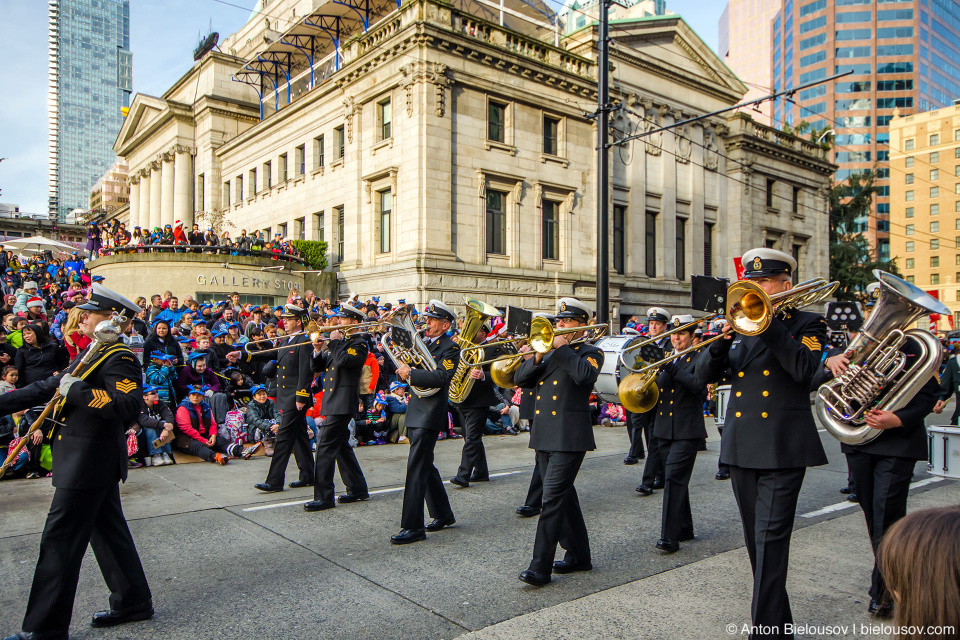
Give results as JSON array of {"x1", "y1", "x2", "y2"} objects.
[{"x1": 303, "y1": 303, "x2": 370, "y2": 511}]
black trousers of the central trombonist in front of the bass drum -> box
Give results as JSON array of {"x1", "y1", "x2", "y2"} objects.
[{"x1": 530, "y1": 451, "x2": 591, "y2": 575}]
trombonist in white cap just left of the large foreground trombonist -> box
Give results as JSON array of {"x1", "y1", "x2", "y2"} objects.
[{"x1": 653, "y1": 315, "x2": 707, "y2": 553}]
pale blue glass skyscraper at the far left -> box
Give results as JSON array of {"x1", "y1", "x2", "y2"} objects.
[{"x1": 47, "y1": 0, "x2": 133, "y2": 220}]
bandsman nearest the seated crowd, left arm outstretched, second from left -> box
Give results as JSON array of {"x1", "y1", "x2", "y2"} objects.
[{"x1": 244, "y1": 304, "x2": 314, "y2": 492}]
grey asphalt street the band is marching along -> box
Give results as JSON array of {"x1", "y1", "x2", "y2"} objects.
[{"x1": 0, "y1": 417, "x2": 960, "y2": 640}]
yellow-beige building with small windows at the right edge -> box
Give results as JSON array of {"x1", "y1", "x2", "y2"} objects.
[{"x1": 890, "y1": 105, "x2": 960, "y2": 330}]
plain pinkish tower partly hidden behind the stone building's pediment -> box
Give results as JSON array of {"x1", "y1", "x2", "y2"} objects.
[{"x1": 719, "y1": 0, "x2": 780, "y2": 124}]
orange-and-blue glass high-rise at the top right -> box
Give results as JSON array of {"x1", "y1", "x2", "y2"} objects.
[{"x1": 773, "y1": 0, "x2": 960, "y2": 259}]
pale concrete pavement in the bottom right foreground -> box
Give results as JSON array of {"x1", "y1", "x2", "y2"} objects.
[{"x1": 460, "y1": 481, "x2": 960, "y2": 640}]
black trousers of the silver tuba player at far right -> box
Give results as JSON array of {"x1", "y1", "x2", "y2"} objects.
[{"x1": 847, "y1": 451, "x2": 917, "y2": 604}]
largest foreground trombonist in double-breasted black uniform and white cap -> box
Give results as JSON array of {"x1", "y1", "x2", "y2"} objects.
[{"x1": 697, "y1": 248, "x2": 827, "y2": 638}]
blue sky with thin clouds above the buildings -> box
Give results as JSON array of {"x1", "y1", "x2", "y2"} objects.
[{"x1": 0, "y1": 0, "x2": 724, "y2": 213}]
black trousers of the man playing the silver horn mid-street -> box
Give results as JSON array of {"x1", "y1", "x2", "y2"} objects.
[{"x1": 400, "y1": 427, "x2": 453, "y2": 529}]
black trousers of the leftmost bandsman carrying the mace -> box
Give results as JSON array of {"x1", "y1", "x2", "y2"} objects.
[{"x1": 23, "y1": 483, "x2": 151, "y2": 634}]
